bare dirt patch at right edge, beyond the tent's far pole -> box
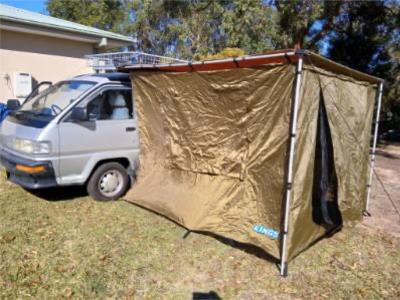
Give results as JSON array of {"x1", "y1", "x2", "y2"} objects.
[{"x1": 363, "y1": 144, "x2": 400, "y2": 237}]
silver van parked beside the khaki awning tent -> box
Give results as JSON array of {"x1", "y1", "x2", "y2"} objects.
[{"x1": 0, "y1": 73, "x2": 139, "y2": 201}]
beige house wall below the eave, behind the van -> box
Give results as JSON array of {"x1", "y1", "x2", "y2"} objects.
[{"x1": 0, "y1": 30, "x2": 94, "y2": 102}]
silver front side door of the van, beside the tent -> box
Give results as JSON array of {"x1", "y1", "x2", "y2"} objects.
[{"x1": 59, "y1": 86, "x2": 139, "y2": 184}]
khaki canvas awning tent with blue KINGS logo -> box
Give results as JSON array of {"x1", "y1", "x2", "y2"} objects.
[{"x1": 122, "y1": 50, "x2": 383, "y2": 275}]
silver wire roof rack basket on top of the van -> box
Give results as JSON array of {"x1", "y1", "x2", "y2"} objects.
[{"x1": 85, "y1": 51, "x2": 188, "y2": 71}]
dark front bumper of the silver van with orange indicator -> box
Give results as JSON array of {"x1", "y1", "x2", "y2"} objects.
[{"x1": 0, "y1": 149, "x2": 57, "y2": 189}]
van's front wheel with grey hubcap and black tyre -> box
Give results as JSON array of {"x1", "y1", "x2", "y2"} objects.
[{"x1": 86, "y1": 162, "x2": 129, "y2": 201}]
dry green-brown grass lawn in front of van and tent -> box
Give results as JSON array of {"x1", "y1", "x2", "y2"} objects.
[{"x1": 0, "y1": 171, "x2": 400, "y2": 299}]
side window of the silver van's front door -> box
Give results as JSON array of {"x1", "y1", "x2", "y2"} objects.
[{"x1": 87, "y1": 90, "x2": 133, "y2": 120}]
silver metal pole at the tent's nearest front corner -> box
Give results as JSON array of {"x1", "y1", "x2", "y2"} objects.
[{"x1": 280, "y1": 57, "x2": 303, "y2": 276}]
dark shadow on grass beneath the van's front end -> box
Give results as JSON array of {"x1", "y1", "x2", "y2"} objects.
[{"x1": 26, "y1": 185, "x2": 88, "y2": 201}]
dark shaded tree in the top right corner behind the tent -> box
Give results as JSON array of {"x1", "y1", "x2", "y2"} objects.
[{"x1": 328, "y1": 1, "x2": 400, "y2": 125}]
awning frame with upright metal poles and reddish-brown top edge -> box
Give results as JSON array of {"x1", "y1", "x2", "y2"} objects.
[{"x1": 122, "y1": 49, "x2": 383, "y2": 277}]
